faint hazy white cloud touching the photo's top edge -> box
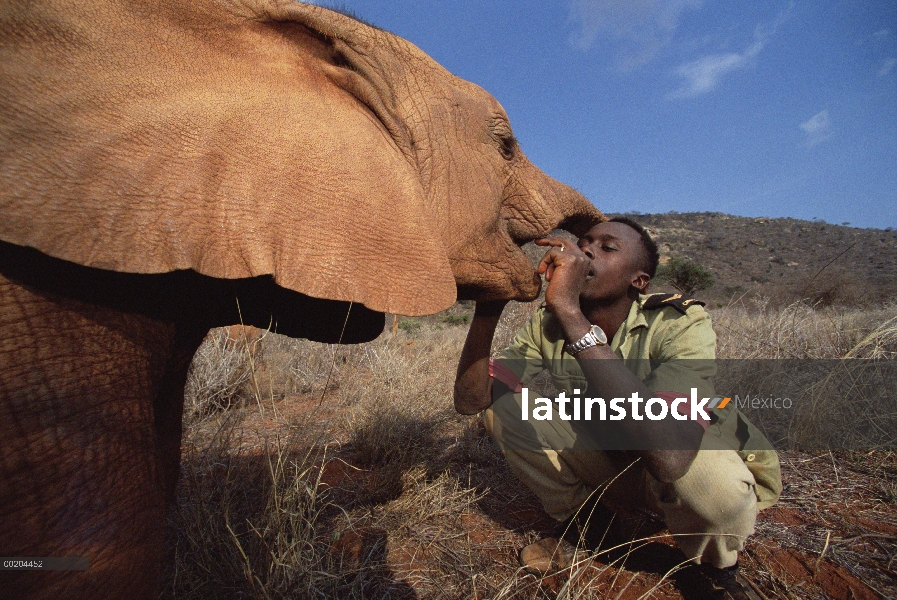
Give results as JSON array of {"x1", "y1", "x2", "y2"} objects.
[{"x1": 570, "y1": 0, "x2": 703, "y2": 69}]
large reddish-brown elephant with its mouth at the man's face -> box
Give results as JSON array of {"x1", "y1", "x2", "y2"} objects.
[{"x1": 0, "y1": 0, "x2": 604, "y2": 598}]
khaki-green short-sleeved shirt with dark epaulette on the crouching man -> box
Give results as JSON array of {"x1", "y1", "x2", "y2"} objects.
[{"x1": 498, "y1": 295, "x2": 782, "y2": 509}]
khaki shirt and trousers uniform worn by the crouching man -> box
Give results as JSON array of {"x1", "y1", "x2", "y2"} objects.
[{"x1": 484, "y1": 294, "x2": 782, "y2": 567}]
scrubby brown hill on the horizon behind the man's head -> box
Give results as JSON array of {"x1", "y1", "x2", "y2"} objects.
[{"x1": 626, "y1": 212, "x2": 897, "y2": 305}]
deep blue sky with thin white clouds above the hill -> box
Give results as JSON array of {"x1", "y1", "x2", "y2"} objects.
[{"x1": 319, "y1": 0, "x2": 897, "y2": 229}]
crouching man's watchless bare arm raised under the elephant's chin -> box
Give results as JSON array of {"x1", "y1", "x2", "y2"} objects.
[{"x1": 455, "y1": 301, "x2": 507, "y2": 415}]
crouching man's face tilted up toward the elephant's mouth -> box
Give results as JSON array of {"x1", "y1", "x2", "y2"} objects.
[{"x1": 577, "y1": 222, "x2": 648, "y2": 300}]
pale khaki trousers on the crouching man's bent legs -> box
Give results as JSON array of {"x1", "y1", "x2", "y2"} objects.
[{"x1": 483, "y1": 403, "x2": 757, "y2": 568}]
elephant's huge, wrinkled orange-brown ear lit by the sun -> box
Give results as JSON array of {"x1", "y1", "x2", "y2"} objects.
[{"x1": 0, "y1": 1, "x2": 456, "y2": 315}]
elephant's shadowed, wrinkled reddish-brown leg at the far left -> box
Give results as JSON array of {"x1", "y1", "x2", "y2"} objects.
[{"x1": 0, "y1": 275, "x2": 182, "y2": 599}]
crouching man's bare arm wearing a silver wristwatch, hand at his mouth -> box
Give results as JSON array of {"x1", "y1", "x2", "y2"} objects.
[{"x1": 539, "y1": 240, "x2": 704, "y2": 482}]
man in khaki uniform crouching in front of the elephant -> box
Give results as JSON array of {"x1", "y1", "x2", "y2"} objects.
[{"x1": 455, "y1": 218, "x2": 781, "y2": 598}]
